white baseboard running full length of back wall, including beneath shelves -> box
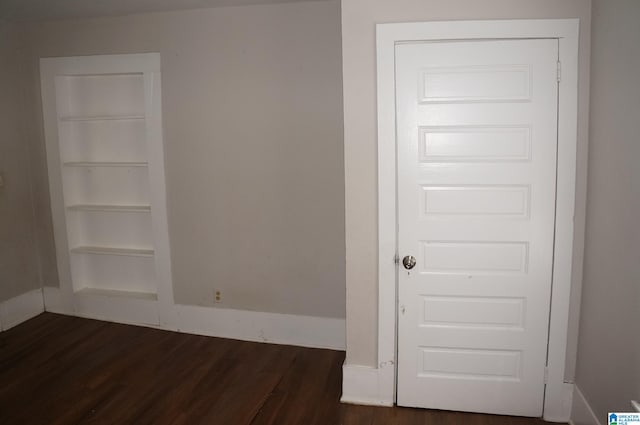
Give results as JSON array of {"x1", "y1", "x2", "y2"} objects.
[{"x1": 44, "y1": 287, "x2": 345, "y2": 350}]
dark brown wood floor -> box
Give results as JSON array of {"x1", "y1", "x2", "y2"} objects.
[{"x1": 0, "y1": 313, "x2": 556, "y2": 425}]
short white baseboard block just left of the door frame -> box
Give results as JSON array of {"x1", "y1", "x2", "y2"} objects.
[{"x1": 340, "y1": 364, "x2": 394, "y2": 406}]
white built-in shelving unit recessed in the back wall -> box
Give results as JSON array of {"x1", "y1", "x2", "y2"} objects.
[{"x1": 41, "y1": 54, "x2": 170, "y2": 323}]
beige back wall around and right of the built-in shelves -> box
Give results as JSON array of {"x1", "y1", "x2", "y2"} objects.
[{"x1": 24, "y1": 1, "x2": 345, "y2": 317}]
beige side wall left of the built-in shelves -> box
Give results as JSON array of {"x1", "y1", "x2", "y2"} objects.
[{"x1": 0, "y1": 21, "x2": 41, "y2": 301}]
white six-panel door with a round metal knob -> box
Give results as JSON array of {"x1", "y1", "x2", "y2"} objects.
[{"x1": 396, "y1": 39, "x2": 558, "y2": 416}]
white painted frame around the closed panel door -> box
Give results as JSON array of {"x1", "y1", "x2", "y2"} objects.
[{"x1": 376, "y1": 19, "x2": 579, "y2": 422}]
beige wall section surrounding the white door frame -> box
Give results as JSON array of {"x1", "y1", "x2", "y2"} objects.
[{"x1": 342, "y1": 0, "x2": 591, "y2": 372}]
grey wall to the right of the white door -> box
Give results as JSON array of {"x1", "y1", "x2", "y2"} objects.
[{"x1": 576, "y1": 0, "x2": 640, "y2": 423}]
